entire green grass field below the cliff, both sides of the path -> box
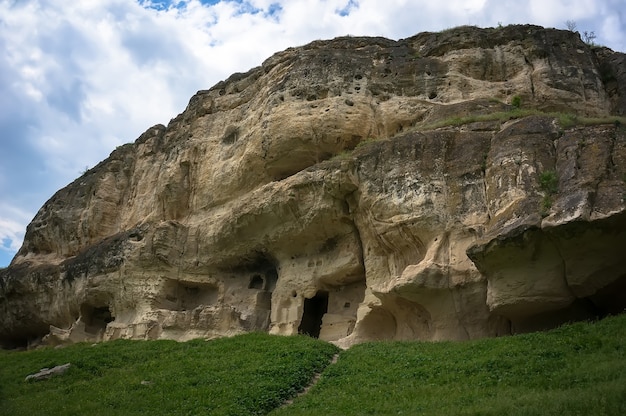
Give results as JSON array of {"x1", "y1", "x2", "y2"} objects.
[{"x1": 0, "y1": 314, "x2": 626, "y2": 416}]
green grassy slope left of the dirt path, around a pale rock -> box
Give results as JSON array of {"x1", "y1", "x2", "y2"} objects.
[{"x1": 0, "y1": 333, "x2": 337, "y2": 416}]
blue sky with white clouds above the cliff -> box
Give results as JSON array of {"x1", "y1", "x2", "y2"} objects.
[{"x1": 0, "y1": 0, "x2": 626, "y2": 267}]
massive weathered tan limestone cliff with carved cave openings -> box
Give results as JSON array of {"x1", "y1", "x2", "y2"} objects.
[{"x1": 0, "y1": 26, "x2": 626, "y2": 347}]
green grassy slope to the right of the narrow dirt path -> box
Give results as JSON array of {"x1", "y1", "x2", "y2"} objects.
[{"x1": 272, "y1": 314, "x2": 626, "y2": 416}]
